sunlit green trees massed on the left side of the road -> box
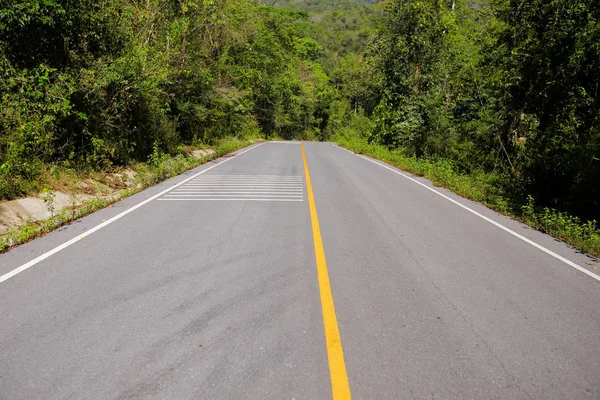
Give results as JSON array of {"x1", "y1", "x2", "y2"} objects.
[{"x1": 0, "y1": 0, "x2": 354, "y2": 199}]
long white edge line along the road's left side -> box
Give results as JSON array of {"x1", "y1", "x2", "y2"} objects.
[{"x1": 0, "y1": 143, "x2": 264, "y2": 283}]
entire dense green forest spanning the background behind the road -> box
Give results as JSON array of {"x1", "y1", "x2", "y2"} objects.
[{"x1": 0, "y1": 0, "x2": 600, "y2": 248}]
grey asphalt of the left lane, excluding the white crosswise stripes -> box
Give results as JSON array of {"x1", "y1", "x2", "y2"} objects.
[{"x1": 0, "y1": 144, "x2": 330, "y2": 400}]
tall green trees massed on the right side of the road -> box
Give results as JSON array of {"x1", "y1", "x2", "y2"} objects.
[{"x1": 370, "y1": 0, "x2": 600, "y2": 222}]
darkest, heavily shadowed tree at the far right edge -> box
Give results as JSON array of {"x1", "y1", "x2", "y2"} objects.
[{"x1": 497, "y1": 0, "x2": 600, "y2": 217}]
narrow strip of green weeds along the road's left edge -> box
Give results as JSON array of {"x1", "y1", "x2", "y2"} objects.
[{"x1": 0, "y1": 139, "x2": 252, "y2": 253}]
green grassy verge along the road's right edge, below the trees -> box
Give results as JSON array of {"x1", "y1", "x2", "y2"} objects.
[{"x1": 337, "y1": 137, "x2": 600, "y2": 257}]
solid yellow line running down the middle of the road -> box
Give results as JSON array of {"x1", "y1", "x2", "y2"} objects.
[{"x1": 300, "y1": 143, "x2": 351, "y2": 400}]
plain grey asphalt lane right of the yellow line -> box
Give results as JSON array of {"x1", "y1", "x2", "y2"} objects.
[{"x1": 306, "y1": 144, "x2": 600, "y2": 399}]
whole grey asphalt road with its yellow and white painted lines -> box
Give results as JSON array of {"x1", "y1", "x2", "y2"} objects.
[{"x1": 0, "y1": 143, "x2": 600, "y2": 400}]
